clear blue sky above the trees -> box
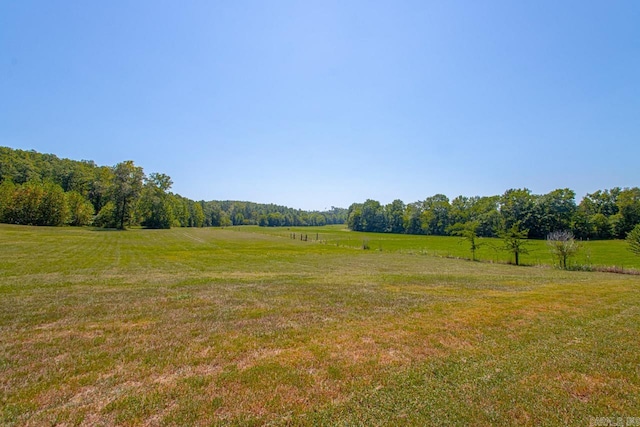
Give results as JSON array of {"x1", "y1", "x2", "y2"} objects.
[{"x1": 0, "y1": 0, "x2": 640, "y2": 210}]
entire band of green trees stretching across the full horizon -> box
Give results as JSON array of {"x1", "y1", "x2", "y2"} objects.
[{"x1": 0, "y1": 147, "x2": 640, "y2": 239}]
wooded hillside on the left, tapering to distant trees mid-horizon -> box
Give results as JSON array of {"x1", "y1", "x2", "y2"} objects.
[{"x1": 0, "y1": 147, "x2": 347, "y2": 228}]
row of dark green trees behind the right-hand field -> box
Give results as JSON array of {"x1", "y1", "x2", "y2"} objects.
[{"x1": 347, "y1": 187, "x2": 640, "y2": 239}]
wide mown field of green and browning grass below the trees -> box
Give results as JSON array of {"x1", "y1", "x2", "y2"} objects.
[{"x1": 0, "y1": 225, "x2": 640, "y2": 426}]
